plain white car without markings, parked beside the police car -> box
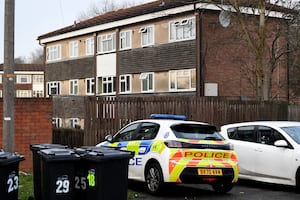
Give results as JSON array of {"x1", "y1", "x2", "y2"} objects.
[{"x1": 221, "y1": 121, "x2": 300, "y2": 188}]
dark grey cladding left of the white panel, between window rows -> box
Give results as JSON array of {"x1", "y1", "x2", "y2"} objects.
[{"x1": 45, "y1": 57, "x2": 95, "y2": 82}]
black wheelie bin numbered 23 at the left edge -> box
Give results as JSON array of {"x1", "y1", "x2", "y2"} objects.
[{"x1": 0, "y1": 150, "x2": 25, "y2": 200}]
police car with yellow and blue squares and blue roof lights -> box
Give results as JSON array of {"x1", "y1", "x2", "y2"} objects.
[{"x1": 97, "y1": 114, "x2": 238, "y2": 194}]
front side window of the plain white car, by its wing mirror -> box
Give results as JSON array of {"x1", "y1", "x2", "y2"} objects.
[{"x1": 257, "y1": 126, "x2": 284, "y2": 145}]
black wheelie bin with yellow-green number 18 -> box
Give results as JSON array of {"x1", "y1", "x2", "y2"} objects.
[{"x1": 75, "y1": 147, "x2": 133, "y2": 200}]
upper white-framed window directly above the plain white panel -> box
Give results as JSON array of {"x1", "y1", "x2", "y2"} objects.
[{"x1": 97, "y1": 33, "x2": 116, "y2": 53}]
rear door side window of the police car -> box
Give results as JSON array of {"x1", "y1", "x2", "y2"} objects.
[{"x1": 132, "y1": 122, "x2": 159, "y2": 140}]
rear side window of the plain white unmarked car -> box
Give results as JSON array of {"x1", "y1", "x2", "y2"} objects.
[{"x1": 227, "y1": 126, "x2": 257, "y2": 142}]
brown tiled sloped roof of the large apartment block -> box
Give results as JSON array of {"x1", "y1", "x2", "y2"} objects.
[{"x1": 37, "y1": 0, "x2": 290, "y2": 40}]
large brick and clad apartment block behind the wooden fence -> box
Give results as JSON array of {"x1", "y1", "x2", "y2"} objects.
[{"x1": 38, "y1": 0, "x2": 288, "y2": 126}]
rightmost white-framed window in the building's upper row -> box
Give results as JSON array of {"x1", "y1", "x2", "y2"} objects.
[{"x1": 169, "y1": 17, "x2": 196, "y2": 42}]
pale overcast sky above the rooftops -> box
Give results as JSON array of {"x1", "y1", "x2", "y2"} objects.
[{"x1": 0, "y1": 0, "x2": 150, "y2": 63}]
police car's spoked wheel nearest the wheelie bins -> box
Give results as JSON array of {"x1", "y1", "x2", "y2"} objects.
[{"x1": 145, "y1": 163, "x2": 164, "y2": 194}]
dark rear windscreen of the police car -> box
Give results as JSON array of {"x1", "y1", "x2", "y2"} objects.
[{"x1": 171, "y1": 124, "x2": 224, "y2": 140}]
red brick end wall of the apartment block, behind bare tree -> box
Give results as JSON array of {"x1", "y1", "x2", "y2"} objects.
[{"x1": 202, "y1": 11, "x2": 288, "y2": 100}]
